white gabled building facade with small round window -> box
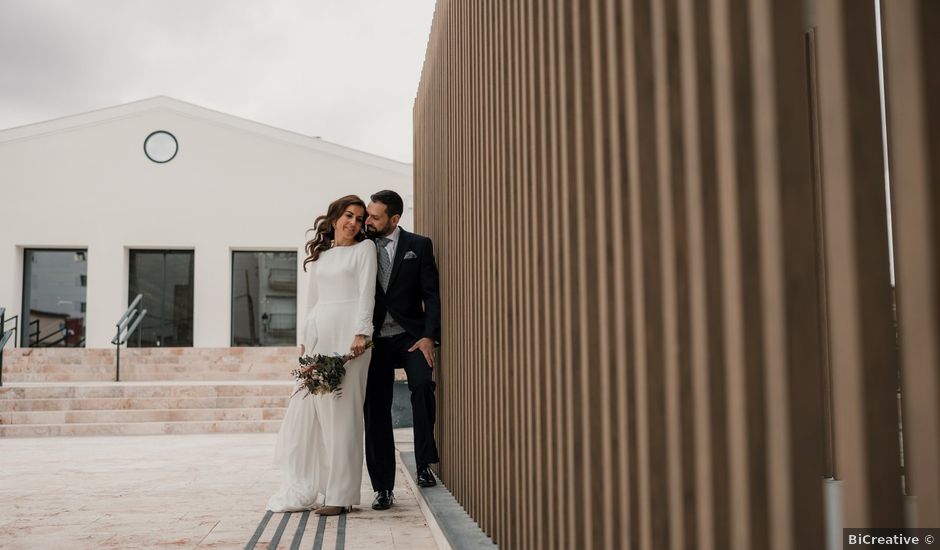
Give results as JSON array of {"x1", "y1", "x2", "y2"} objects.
[{"x1": 0, "y1": 98, "x2": 412, "y2": 347}]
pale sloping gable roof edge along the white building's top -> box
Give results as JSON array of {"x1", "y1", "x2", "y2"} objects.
[{"x1": 0, "y1": 96, "x2": 411, "y2": 175}]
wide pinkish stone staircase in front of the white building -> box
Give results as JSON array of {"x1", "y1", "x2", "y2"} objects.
[{"x1": 0, "y1": 347, "x2": 297, "y2": 437}]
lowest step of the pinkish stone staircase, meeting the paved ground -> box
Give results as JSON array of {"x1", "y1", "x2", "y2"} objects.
[{"x1": 0, "y1": 420, "x2": 281, "y2": 437}]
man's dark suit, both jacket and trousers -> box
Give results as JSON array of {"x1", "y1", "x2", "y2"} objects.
[{"x1": 364, "y1": 229, "x2": 441, "y2": 491}]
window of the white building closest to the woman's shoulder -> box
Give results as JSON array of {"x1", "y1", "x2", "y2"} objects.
[{"x1": 232, "y1": 252, "x2": 297, "y2": 346}]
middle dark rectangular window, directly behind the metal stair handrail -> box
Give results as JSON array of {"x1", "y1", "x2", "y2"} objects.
[{"x1": 127, "y1": 250, "x2": 193, "y2": 347}]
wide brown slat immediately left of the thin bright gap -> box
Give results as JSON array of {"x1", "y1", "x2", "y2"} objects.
[{"x1": 818, "y1": 0, "x2": 903, "y2": 527}]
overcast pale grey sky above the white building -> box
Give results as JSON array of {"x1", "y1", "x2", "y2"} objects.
[{"x1": 0, "y1": 0, "x2": 434, "y2": 162}]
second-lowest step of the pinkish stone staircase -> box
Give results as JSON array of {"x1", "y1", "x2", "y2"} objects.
[{"x1": 0, "y1": 407, "x2": 285, "y2": 425}]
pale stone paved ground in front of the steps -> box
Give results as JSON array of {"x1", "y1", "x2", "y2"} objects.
[{"x1": 0, "y1": 429, "x2": 437, "y2": 550}]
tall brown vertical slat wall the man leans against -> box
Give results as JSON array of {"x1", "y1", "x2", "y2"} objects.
[{"x1": 414, "y1": 0, "x2": 940, "y2": 550}]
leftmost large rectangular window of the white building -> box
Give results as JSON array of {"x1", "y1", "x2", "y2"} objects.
[{"x1": 20, "y1": 250, "x2": 88, "y2": 347}]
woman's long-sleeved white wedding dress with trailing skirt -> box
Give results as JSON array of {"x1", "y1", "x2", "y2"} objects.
[{"x1": 267, "y1": 240, "x2": 376, "y2": 512}]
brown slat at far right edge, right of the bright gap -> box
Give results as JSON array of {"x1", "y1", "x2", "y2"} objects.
[{"x1": 883, "y1": 0, "x2": 940, "y2": 527}]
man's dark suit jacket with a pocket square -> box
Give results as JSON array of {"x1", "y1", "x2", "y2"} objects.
[{"x1": 372, "y1": 229, "x2": 441, "y2": 343}]
